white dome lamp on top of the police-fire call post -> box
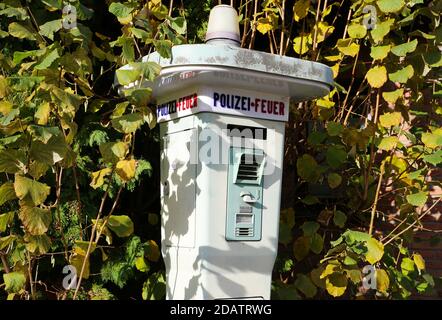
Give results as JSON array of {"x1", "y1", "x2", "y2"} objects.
[{"x1": 206, "y1": 4, "x2": 241, "y2": 47}]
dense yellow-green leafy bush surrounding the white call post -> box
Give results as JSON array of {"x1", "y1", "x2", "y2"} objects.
[{"x1": 0, "y1": 0, "x2": 442, "y2": 299}]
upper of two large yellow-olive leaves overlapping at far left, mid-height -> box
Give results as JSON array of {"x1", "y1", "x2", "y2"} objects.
[{"x1": 14, "y1": 175, "x2": 51, "y2": 206}]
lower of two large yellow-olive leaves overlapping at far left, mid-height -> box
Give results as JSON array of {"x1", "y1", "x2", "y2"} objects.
[{"x1": 18, "y1": 206, "x2": 52, "y2": 236}]
